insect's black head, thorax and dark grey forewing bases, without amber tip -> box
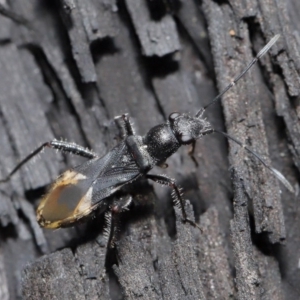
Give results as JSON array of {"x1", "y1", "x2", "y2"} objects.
[{"x1": 85, "y1": 114, "x2": 212, "y2": 204}]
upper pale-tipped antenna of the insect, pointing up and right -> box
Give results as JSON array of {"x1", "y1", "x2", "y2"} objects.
[{"x1": 196, "y1": 34, "x2": 280, "y2": 117}]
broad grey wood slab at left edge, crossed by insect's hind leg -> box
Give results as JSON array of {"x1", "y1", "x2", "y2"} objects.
[{"x1": 0, "y1": 44, "x2": 59, "y2": 192}]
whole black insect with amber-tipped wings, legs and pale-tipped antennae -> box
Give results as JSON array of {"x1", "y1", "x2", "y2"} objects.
[{"x1": 0, "y1": 35, "x2": 293, "y2": 247}]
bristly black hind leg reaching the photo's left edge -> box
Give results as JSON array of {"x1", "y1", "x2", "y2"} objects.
[{"x1": 0, "y1": 140, "x2": 97, "y2": 183}]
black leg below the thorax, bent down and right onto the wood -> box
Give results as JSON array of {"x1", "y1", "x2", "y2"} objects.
[{"x1": 146, "y1": 174, "x2": 201, "y2": 229}]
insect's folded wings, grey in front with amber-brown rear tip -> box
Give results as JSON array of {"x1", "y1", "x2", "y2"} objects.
[{"x1": 37, "y1": 142, "x2": 140, "y2": 228}]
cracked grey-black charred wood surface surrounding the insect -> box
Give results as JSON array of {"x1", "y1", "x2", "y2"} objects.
[{"x1": 0, "y1": 0, "x2": 300, "y2": 300}]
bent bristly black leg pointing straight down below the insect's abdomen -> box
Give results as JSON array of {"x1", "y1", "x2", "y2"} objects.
[{"x1": 104, "y1": 196, "x2": 132, "y2": 249}]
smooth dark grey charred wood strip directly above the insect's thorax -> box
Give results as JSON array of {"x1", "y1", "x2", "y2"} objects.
[{"x1": 95, "y1": 7, "x2": 163, "y2": 133}]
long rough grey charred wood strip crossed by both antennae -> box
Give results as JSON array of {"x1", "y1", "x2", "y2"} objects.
[{"x1": 204, "y1": 1, "x2": 286, "y2": 242}]
